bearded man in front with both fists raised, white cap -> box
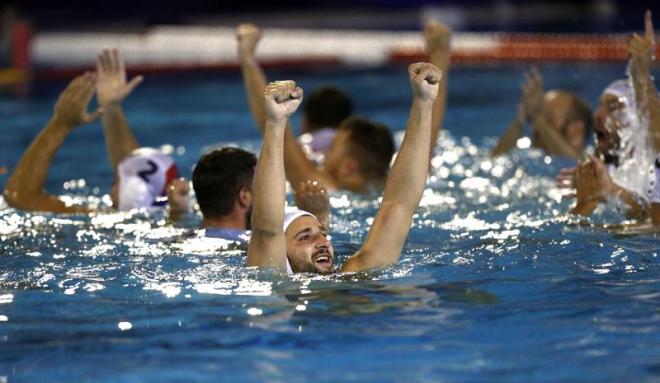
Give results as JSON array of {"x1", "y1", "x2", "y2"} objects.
[{"x1": 247, "y1": 63, "x2": 442, "y2": 273}]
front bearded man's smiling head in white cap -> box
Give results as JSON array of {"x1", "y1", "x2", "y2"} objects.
[{"x1": 284, "y1": 208, "x2": 335, "y2": 274}]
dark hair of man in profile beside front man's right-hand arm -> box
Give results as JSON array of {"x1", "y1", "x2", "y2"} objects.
[{"x1": 339, "y1": 117, "x2": 394, "y2": 179}]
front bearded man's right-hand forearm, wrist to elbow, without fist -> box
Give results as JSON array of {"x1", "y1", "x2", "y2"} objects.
[{"x1": 383, "y1": 100, "x2": 432, "y2": 211}]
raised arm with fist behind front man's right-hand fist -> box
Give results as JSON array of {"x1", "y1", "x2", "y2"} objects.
[{"x1": 424, "y1": 20, "x2": 451, "y2": 161}]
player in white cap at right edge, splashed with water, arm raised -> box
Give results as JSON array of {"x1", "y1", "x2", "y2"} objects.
[{"x1": 557, "y1": 11, "x2": 660, "y2": 223}]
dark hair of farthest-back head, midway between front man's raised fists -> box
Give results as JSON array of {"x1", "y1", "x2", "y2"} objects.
[{"x1": 303, "y1": 85, "x2": 353, "y2": 131}]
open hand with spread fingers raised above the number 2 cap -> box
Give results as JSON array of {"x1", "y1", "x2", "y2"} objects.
[{"x1": 96, "y1": 49, "x2": 143, "y2": 108}]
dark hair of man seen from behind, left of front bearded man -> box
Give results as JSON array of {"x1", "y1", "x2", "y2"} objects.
[{"x1": 192, "y1": 147, "x2": 257, "y2": 218}]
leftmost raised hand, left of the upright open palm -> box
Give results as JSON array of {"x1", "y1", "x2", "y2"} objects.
[{"x1": 53, "y1": 72, "x2": 102, "y2": 129}]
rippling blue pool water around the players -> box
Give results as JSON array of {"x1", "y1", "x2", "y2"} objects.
[{"x1": 0, "y1": 63, "x2": 660, "y2": 382}]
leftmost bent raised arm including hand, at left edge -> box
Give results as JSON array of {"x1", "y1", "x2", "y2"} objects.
[{"x1": 4, "y1": 73, "x2": 101, "y2": 213}]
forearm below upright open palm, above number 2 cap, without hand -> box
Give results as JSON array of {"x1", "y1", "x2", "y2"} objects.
[{"x1": 102, "y1": 105, "x2": 140, "y2": 169}]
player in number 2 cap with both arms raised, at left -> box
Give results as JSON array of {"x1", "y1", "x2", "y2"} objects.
[{"x1": 4, "y1": 50, "x2": 189, "y2": 214}]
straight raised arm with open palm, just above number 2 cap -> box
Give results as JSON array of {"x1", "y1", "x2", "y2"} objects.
[{"x1": 96, "y1": 49, "x2": 142, "y2": 170}]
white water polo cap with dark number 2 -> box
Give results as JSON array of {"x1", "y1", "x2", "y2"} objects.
[{"x1": 117, "y1": 148, "x2": 179, "y2": 210}]
